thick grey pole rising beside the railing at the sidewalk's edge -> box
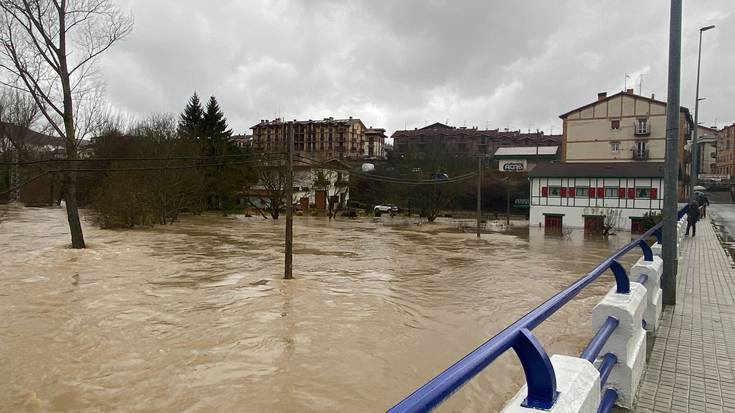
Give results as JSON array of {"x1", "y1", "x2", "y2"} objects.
[{"x1": 661, "y1": 0, "x2": 682, "y2": 305}]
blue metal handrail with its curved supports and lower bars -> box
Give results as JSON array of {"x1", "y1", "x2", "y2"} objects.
[{"x1": 388, "y1": 207, "x2": 686, "y2": 413}]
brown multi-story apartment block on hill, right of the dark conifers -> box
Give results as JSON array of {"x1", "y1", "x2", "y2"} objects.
[{"x1": 251, "y1": 117, "x2": 367, "y2": 160}]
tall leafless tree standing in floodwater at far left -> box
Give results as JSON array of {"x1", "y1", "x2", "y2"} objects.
[{"x1": 0, "y1": 0, "x2": 133, "y2": 248}]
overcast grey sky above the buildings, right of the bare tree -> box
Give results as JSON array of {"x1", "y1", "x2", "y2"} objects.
[{"x1": 100, "y1": 0, "x2": 735, "y2": 134}]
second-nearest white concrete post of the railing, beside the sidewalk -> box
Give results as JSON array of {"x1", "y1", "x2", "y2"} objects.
[{"x1": 592, "y1": 283, "x2": 647, "y2": 409}]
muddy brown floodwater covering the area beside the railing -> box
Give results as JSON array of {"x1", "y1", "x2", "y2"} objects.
[{"x1": 0, "y1": 207, "x2": 644, "y2": 412}]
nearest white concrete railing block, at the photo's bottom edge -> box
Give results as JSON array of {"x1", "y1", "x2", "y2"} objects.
[{"x1": 502, "y1": 354, "x2": 600, "y2": 413}]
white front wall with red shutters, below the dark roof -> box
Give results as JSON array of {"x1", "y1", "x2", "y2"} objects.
[{"x1": 529, "y1": 177, "x2": 663, "y2": 230}]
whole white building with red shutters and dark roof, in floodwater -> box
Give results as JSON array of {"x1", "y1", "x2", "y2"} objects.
[{"x1": 529, "y1": 162, "x2": 664, "y2": 232}]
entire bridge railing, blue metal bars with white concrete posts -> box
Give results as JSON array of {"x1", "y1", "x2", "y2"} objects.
[{"x1": 388, "y1": 208, "x2": 686, "y2": 413}]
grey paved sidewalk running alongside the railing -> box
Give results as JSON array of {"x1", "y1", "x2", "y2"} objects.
[{"x1": 635, "y1": 219, "x2": 735, "y2": 413}]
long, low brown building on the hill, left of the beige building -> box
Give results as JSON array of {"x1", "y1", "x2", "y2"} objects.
[{"x1": 392, "y1": 123, "x2": 561, "y2": 157}]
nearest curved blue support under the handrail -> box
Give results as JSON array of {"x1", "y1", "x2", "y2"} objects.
[{"x1": 513, "y1": 328, "x2": 559, "y2": 410}]
